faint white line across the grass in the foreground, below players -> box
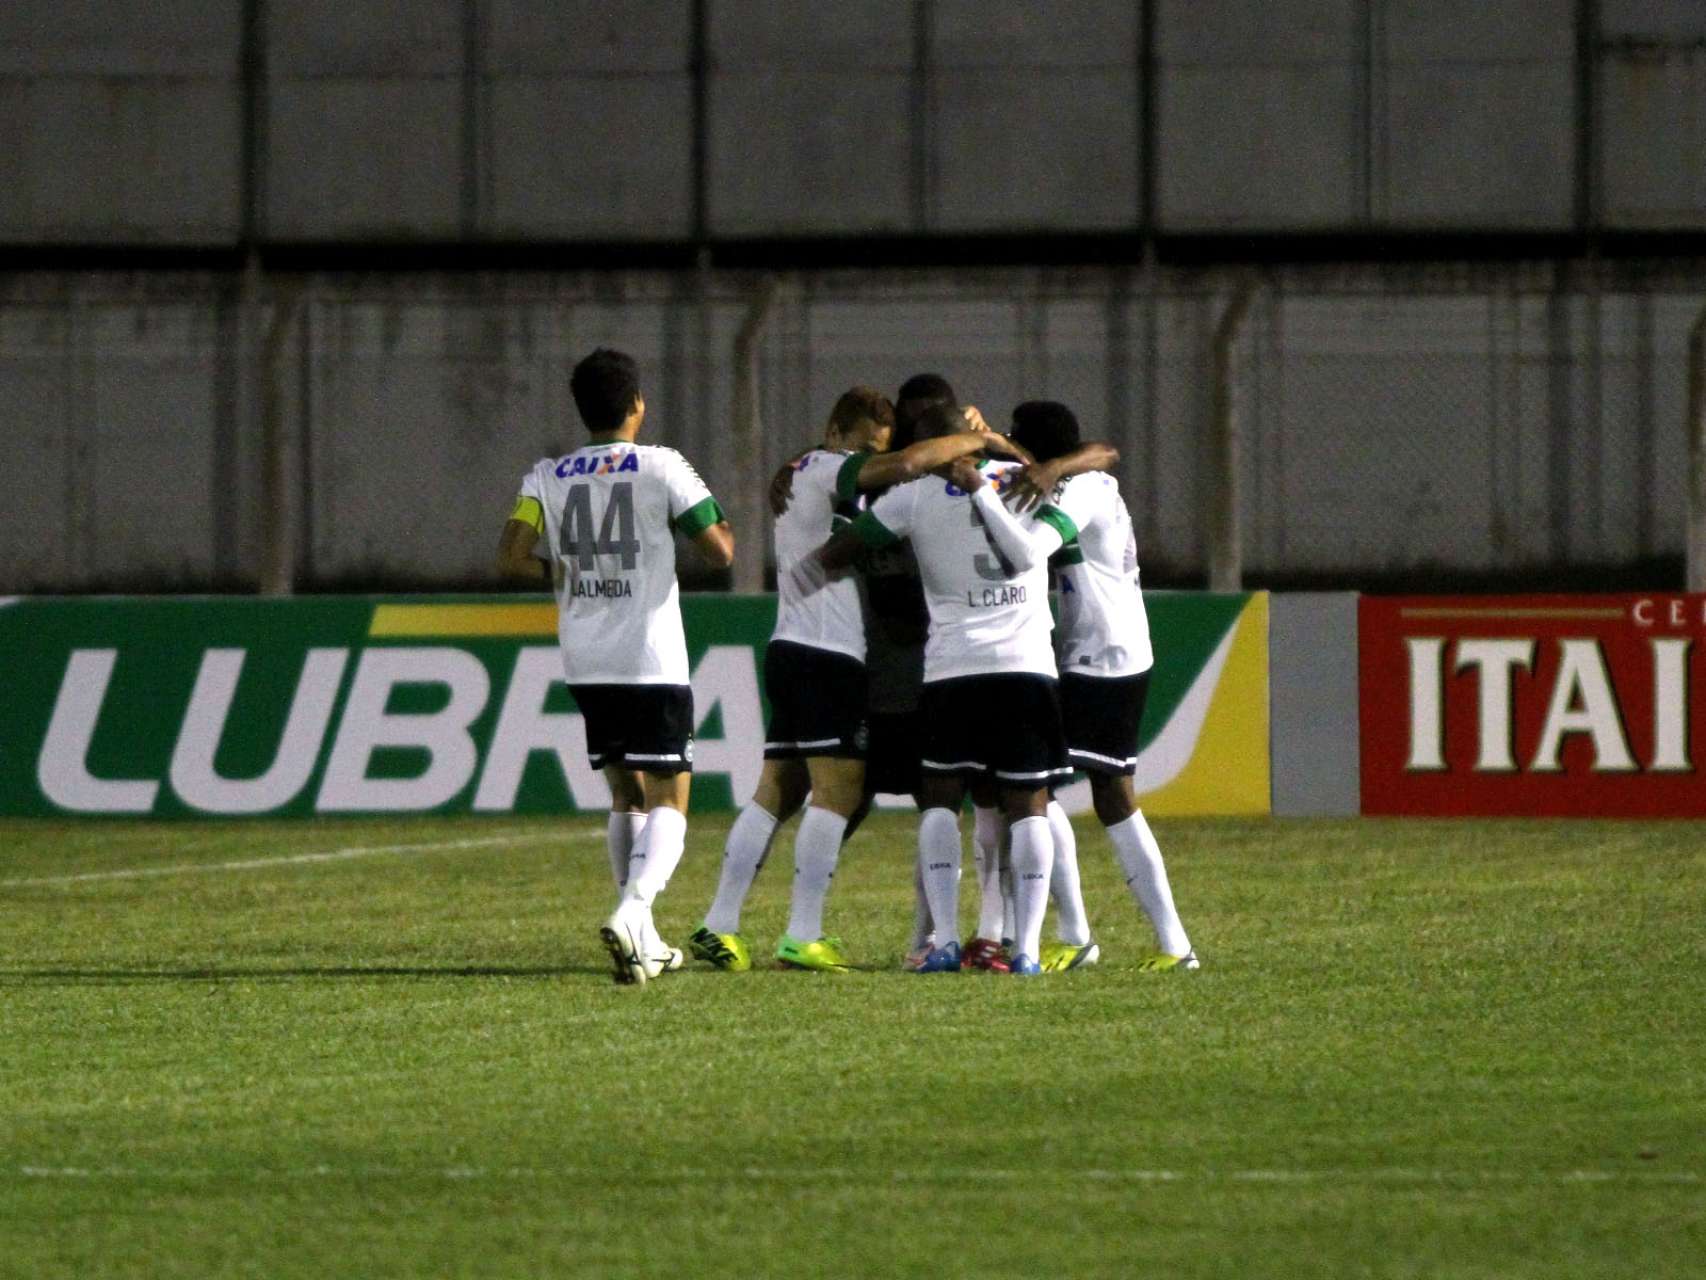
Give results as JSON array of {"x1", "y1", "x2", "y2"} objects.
[{"x1": 0, "y1": 1164, "x2": 1706, "y2": 1186}]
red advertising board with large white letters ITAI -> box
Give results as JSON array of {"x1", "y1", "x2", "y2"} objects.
[{"x1": 1358, "y1": 596, "x2": 1706, "y2": 816}]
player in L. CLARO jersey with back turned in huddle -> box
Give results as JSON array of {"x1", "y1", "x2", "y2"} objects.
[{"x1": 797, "y1": 408, "x2": 1071, "y2": 975}]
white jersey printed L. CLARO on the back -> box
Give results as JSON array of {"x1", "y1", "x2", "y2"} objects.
[{"x1": 855, "y1": 463, "x2": 1054, "y2": 684}]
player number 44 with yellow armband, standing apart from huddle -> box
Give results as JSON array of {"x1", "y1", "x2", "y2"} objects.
[{"x1": 498, "y1": 348, "x2": 734, "y2": 983}]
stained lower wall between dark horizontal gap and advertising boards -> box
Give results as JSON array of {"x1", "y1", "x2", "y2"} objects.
[{"x1": 0, "y1": 263, "x2": 1706, "y2": 592}]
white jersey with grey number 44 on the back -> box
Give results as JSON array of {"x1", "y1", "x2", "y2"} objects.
[{"x1": 520, "y1": 440, "x2": 723, "y2": 684}]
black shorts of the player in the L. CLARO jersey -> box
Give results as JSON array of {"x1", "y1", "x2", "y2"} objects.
[{"x1": 921, "y1": 672, "x2": 1071, "y2": 787}]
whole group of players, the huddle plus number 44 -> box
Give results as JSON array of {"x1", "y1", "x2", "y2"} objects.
[{"x1": 498, "y1": 348, "x2": 1198, "y2": 983}]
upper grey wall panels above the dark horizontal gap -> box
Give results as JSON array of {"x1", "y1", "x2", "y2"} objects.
[{"x1": 0, "y1": 0, "x2": 1706, "y2": 244}]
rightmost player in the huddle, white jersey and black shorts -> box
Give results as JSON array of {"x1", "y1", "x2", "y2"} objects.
[{"x1": 1010, "y1": 401, "x2": 1198, "y2": 973}]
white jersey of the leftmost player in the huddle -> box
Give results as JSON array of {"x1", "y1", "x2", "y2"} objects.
[{"x1": 771, "y1": 449, "x2": 868, "y2": 662}]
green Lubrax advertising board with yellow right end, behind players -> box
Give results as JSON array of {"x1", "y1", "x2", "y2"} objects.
[{"x1": 0, "y1": 594, "x2": 1269, "y2": 817}]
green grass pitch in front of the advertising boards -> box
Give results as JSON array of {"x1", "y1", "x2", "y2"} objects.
[{"x1": 0, "y1": 816, "x2": 1706, "y2": 1280}]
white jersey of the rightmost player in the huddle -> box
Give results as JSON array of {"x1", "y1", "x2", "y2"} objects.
[{"x1": 1051, "y1": 471, "x2": 1155, "y2": 676}]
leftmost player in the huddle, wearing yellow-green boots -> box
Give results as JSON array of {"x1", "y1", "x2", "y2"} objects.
[{"x1": 688, "y1": 387, "x2": 1017, "y2": 971}]
